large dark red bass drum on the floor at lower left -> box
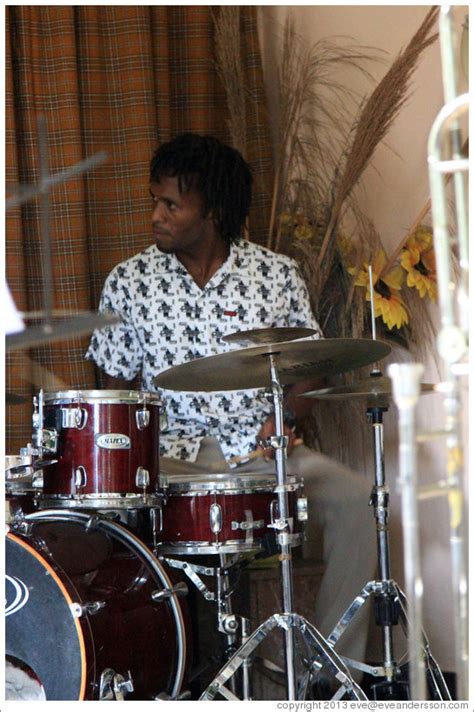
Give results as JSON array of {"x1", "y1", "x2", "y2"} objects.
[{"x1": 5, "y1": 511, "x2": 189, "y2": 700}]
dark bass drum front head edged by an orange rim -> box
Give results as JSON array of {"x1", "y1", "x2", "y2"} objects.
[{"x1": 5, "y1": 534, "x2": 86, "y2": 700}]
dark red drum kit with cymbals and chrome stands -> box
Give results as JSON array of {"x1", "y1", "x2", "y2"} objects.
[{"x1": 6, "y1": 329, "x2": 449, "y2": 700}]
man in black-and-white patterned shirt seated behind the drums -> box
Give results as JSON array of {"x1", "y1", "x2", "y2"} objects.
[{"x1": 86, "y1": 134, "x2": 376, "y2": 672}]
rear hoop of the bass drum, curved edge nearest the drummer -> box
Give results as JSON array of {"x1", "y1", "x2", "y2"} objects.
[{"x1": 25, "y1": 510, "x2": 186, "y2": 699}]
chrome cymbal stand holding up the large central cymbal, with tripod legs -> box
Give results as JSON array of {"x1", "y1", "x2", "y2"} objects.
[{"x1": 200, "y1": 353, "x2": 367, "y2": 700}]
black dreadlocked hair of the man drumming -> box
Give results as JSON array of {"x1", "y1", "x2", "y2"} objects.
[{"x1": 150, "y1": 133, "x2": 252, "y2": 243}]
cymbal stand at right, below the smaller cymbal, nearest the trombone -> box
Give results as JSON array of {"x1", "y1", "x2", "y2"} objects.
[{"x1": 328, "y1": 369, "x2": 451, "y2": 700}]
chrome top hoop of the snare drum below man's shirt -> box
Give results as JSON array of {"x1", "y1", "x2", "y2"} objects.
[{"x1": 159, "y1": 473, "x2": 300, "y2": 496}]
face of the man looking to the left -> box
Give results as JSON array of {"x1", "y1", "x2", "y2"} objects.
[{"x1": 150, "y1": 176, "x2": 214, "y2": 253}]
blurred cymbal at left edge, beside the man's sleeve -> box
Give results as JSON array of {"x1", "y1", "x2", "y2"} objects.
[{"x1": 5, "y1": 312, "x2": 120, "y2": 351}]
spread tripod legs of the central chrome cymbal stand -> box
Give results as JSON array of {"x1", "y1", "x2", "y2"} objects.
[{"x1": 199, "y1": 613, "x2": 367, "y2": 700}]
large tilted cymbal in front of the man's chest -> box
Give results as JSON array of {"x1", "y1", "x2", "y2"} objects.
[{"x1": 154, "y1": 339, "x2": 391, "y2": 391}]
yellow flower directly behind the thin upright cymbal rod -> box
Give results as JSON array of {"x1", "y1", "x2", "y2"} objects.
[{"x1": 348, "y1": 250, "x2": 408, "y2": 329}]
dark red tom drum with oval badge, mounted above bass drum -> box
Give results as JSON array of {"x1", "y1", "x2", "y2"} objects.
[{"x1": 37, "y1": 391, "x2": 161, "y2": 509}]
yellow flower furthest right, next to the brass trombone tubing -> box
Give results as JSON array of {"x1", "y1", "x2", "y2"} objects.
[{"x1": 400, "y1": 225, "x2": 436, "y2": 302}]
